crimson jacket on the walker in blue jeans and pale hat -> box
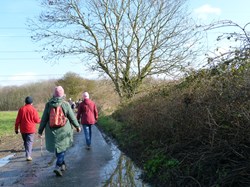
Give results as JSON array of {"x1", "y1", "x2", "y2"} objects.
[{"x1": 77, "y1": 98, "x2": 98, "y2": 125}]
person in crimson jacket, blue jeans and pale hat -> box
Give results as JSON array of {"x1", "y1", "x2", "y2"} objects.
[{"x1": 77, "y1": 92, "x2": 98, "y2": 149}]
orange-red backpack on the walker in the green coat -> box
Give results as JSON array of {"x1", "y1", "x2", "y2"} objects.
[{"x1": 49, "y1": 106, "x2": 67, "y2": 128}]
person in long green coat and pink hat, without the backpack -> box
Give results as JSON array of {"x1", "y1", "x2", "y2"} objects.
[{"x1": 38, "y1": 86, "x2": 81, "y2": 176}]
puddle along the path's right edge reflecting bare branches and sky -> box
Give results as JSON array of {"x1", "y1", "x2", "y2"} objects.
[{"x1": 101, "y1": 144, "x2": 149, "y2": 187}]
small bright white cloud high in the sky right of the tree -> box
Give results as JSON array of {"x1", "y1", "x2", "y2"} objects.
[{"x1": 194, "y1": 4, "x2": 221, "y2": 20}]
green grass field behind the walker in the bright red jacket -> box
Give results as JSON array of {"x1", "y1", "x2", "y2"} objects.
[{"x1": 0, "y1": 111, "x2": 42, "y2": 137}]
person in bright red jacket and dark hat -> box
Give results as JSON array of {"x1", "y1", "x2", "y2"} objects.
[{"x1": 15, "y1": 96, "x2": 41, "y2": 161}]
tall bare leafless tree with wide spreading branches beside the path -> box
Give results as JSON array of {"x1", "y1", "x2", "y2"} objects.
[{"x1": 29, "y1": 0, "x2": 202, "y2": 98}]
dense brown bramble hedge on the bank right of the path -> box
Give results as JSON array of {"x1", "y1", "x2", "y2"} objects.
[{"x1": 110, "y1": 59, "x2": 250, "y2": 186}]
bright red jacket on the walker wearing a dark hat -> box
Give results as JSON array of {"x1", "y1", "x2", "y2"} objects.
[{"x1": 15, "y1": 104, "x2": 41, "y2": 133}]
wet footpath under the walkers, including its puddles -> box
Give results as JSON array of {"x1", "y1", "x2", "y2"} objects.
[{"x1": 0, "y1": 126, "x2": 149, "y2": 187}]
